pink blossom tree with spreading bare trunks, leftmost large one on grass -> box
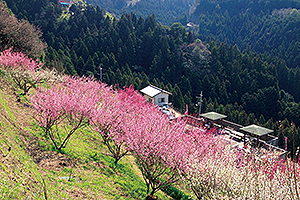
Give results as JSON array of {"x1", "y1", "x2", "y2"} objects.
[{"x1": 30, "y1": 76, "x2": 105, "y2": 150}]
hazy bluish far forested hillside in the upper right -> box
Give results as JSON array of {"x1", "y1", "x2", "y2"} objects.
[{"x1": 190, "y1": 0, "x2": 300, "y2": 80}]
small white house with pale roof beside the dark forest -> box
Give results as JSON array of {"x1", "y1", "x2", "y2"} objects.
[{"x1": 140, "y1": 85, "x2": 172, "y2": 106}]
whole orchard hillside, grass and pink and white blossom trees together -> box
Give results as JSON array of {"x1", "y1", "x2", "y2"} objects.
[{"x1": 0, "y1": 48, "x2": 300, "y2": 200}]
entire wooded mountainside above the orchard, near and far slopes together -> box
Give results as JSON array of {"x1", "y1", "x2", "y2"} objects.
[{"x1": 0, "y1": 0, "x2": 300, "y2": 198}]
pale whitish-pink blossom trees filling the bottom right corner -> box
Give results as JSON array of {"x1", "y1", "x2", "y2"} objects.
[{"x1": 184, "y1": 139, "x2": 300, "y2": 199}]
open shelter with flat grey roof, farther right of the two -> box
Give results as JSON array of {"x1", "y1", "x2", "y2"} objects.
[{"x1": 240, "y1": 124, "x2": 273, "y2": 146}]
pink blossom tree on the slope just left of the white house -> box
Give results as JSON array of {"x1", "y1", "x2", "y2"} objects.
[{"x1": 92, "y1": 87, "x2": 146, "y2": 163}]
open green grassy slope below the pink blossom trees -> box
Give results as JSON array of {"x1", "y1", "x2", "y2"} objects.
[{"x1": 0, "y1": 79, "x2": 169, "y2": 199}]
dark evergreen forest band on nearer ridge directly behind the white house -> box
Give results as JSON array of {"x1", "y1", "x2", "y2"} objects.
[{"x1": 1, "y1": 0, "x2": 300, "y2": 153}]
